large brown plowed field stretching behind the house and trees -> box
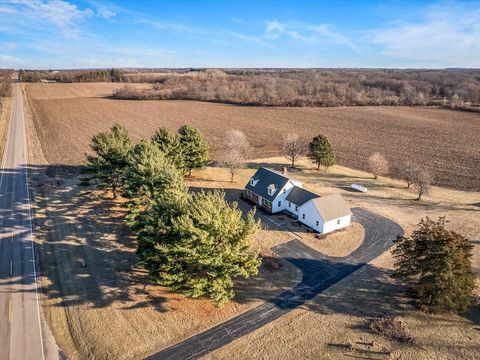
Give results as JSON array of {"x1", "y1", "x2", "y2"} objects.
[{"x1": 26, "y1": 83, "x2": 480, "y2": 191}]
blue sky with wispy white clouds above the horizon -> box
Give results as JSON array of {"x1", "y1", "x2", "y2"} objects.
[{"x1": 0, "y1": 0, "x2": 480, "y2": 69}]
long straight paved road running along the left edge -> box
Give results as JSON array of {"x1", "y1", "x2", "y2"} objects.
[{"x1": 0, "y1": 84, "x2": 45, "y2": 359}]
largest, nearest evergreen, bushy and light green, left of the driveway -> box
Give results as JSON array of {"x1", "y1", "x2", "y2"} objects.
[{"x1": 139, "y1": 192, "x2": 260, "y2": 306}]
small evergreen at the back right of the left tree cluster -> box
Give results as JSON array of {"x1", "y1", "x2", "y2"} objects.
[{"x1": 178, "y1": 125, "x2": 209, "y2": 176}]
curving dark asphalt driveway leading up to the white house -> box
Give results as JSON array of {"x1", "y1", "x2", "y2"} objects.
[{"x1": 150, "y1": 208, "x2": 403, "y2": 360}]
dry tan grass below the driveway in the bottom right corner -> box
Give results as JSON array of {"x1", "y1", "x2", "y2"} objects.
[{"x1": 206, "y1": 253, "x2": 480, "y2": 360}]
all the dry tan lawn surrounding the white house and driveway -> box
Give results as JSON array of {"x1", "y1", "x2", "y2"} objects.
[{"x1": 30, "y1": 158, "x2": 480, "y2": 359}]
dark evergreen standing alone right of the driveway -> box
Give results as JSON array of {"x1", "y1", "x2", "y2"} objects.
[{"x1": 393, "y1": 217, "x2": 475, "y2": 313}]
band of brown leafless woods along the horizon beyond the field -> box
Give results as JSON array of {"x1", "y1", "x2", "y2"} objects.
[{"x1": 16, "y1": 69, "x2": 480, "y2": 108}]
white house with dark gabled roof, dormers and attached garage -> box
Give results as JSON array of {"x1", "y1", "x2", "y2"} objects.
[{"x1": 245, "y1": 167, "x2": 352, "y2": 234}]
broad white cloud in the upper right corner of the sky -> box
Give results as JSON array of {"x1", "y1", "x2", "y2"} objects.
[{"x1": 366, "y1": 5, "x2": 480, "y2": 67}]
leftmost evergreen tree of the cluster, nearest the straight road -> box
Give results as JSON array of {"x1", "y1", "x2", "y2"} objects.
[{"x1": 87, "y1": 124, "x2": 133, "y2": 199}]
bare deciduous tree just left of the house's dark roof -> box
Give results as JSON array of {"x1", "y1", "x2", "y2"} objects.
[{"x1": 222, "y1": 130, "x2": 250, "y2": 182}]
